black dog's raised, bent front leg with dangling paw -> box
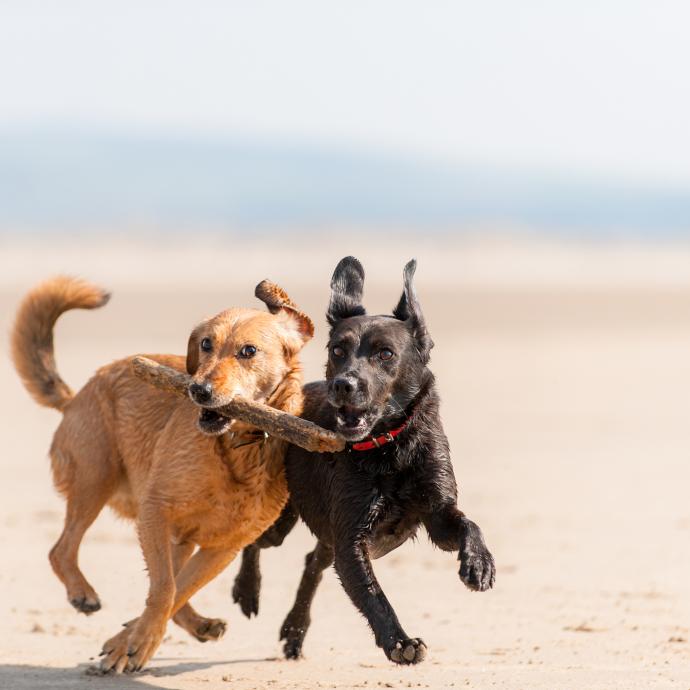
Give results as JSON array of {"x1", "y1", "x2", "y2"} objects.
[{"x1": 424, "y1": 504, "x2": 496, "y2": 592}]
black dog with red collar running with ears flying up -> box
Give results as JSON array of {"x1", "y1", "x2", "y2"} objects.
[{"x1": 233, "y1": 257, "x2": 495, "y2": 664}]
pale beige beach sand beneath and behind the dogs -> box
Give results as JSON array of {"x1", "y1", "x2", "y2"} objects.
[{"x1": 0, "y1": 235, "x2": 690, "y2": 690}]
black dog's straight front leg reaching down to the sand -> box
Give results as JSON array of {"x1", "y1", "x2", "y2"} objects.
[{"x1": 335, "y1": 539, "x2": 426, "y2": 664}]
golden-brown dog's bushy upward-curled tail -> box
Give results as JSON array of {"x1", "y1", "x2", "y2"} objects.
[{"x1": 12, "y1": 276, "x2": 110, "y2": 410}]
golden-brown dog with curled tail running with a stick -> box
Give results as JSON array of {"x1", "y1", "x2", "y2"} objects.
[{"x1": 12, "y1": 277, "x2": 314, "y2": 672}]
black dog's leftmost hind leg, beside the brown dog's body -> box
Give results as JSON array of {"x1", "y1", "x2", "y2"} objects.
[{"x1": 232, "y1": 502, "x2": 298, "y2": 618}]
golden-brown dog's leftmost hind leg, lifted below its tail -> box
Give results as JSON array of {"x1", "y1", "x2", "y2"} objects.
[{"x1": 48, "y1": 485, "x2": 110, "y2": 615}]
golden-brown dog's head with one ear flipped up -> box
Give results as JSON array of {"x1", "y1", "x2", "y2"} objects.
[{"x1": 187, "y1": 280, "x2": 314, "y2": 436}]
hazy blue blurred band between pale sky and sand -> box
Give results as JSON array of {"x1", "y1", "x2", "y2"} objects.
[{"x1": 0, "y1": 127, "x2": 690, "y2": 237}]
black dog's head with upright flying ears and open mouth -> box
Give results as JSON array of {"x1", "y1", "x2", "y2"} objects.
[{"x1": 326, "y1": 256, "x2": 434, "y2": 441}]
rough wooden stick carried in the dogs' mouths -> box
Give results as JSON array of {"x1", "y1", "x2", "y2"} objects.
[{"x1": 132, "y1": 357, "x2": 345, "y2": 453}]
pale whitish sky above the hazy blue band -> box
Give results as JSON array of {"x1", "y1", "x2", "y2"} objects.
[{"x1": 0, "y1": 0, "x2": 690, "y2": 189}]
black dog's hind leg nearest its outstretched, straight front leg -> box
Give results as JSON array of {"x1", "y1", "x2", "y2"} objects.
[{"x1": 280, "y1": 541, "x2": 333, "y2": 659}]
